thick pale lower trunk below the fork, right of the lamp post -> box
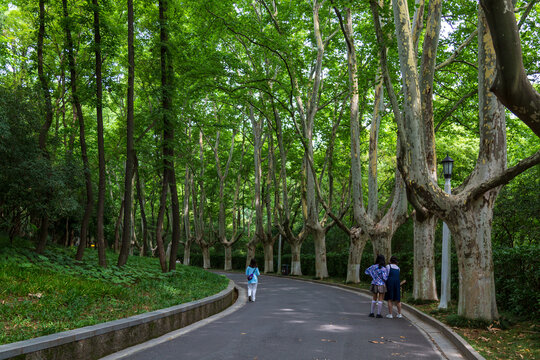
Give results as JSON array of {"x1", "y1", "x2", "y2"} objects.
[{"x1": 449, "y1": 195, "x2": 499, "y2": 321}]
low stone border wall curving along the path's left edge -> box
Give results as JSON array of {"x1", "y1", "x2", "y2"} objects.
[{"x1": 0, "y1": 281, "x2": 238, "y2": 360}]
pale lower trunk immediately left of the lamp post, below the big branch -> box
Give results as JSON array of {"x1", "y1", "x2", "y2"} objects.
[{"x1": 413, "y1": 216, "x2": 438, "y2": 300}]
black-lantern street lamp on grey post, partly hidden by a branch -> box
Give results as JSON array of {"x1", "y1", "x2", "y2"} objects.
[{"x1": 439, "y1": 154, "x2": 454, "y2": 309}]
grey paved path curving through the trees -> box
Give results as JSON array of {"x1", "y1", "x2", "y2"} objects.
[{"x1": 101, "y1": 274, "x2": 442, "y2": 360}]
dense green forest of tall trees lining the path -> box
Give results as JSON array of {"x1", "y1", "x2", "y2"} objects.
[{"x1": 0, "y1": 0, "x2": 540, "y2": 320}]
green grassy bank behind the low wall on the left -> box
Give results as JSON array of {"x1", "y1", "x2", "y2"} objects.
[{"x1": 0, "y1": 240, "x2": 229, "y2": 344}]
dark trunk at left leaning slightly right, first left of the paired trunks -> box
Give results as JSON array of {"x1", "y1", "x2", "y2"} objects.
[{"x1": 118, "y1": 0, "x2": 135, "y2": 266}]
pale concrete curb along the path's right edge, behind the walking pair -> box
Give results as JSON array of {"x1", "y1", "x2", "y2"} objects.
[{"x1": 264, "y1": 274, "x2": 486, "y2": 360}]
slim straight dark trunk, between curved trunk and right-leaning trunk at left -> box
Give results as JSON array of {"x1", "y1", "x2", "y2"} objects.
[{"x1": 92, "y1": 0, "x2": 107, "y2": 267}]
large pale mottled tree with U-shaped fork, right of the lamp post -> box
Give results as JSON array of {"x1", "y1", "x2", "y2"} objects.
[{"x1": 393, "y1": 0, "x2": 540, "y2": 320}]
